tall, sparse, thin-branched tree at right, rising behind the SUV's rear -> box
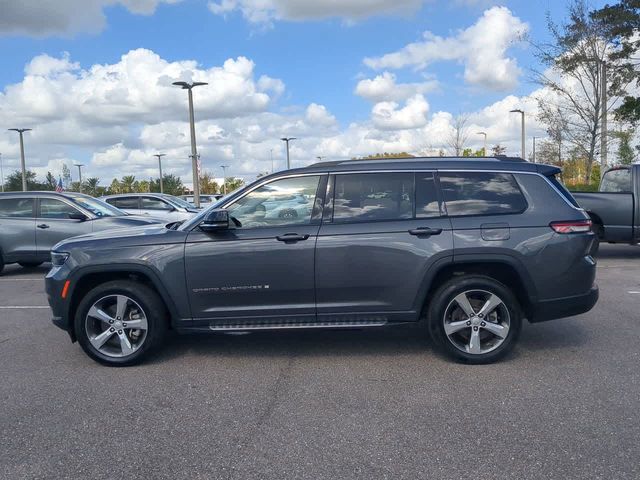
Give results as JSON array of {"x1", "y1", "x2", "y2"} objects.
[{"x1": 536, "y1": 0, "x2": 624, "y2": 183}]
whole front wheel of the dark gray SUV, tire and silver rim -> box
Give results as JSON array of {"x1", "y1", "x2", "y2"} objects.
[{"x1": 74, "y1": 280, "x2": 167, "y2": 366}]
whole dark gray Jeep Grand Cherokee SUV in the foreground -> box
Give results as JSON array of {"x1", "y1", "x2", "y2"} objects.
[{"x1": 46, "y1": 157, "x2": 598, "y2": 365}]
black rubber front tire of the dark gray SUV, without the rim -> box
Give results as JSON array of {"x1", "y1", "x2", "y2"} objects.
[{"x1": 74, "y1": 280, "x2": 168, "y2": 367}]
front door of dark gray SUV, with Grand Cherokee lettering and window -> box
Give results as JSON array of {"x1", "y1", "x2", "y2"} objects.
[{"x1": 185, "y1": 175, "x2": 322, "y2": 323}]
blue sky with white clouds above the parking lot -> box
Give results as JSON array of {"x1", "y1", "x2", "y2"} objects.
[{"x1": 0, "y1": 0, "x2": 604, "y2": 185}]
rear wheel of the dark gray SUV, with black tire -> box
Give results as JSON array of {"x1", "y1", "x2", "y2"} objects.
[{"x1": 427, "y1": 275, "x2": 522, "y2": 364}]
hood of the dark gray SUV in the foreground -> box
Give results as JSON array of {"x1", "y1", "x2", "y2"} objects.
[{"x1": 52, "y1": 223, "x2": 186, "y2": 251}]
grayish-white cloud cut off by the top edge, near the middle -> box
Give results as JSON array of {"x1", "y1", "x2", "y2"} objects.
[{"x1": 208, "y1": 0, "x2": 425, "y2": 23}]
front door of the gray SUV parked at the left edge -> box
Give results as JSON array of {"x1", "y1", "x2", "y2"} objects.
[{"x1": 35, "y1": 198, "x2": 93, "y2": 261}]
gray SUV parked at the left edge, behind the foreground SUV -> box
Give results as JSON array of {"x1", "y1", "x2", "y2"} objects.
[{"x1": 0, "y1": 192, "x2": 159, "y2": 272}]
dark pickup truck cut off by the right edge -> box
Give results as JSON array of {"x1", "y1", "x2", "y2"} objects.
[{"x1": 573, "y1": 164, "x2": 640, "y2": 244}]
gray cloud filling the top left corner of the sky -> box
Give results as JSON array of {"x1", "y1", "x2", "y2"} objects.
[{"x1": 0, "y1": 0, "x2": 182, "y2": 37}]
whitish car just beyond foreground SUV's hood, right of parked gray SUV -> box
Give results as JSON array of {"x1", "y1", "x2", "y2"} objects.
[{"x1": 101, "y1": 193, "x2": 199, "y2": 222}]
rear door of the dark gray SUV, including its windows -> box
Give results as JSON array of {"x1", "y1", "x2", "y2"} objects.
[{"x1": 316, "y1": 172, "x2": 453, "y2": 321}]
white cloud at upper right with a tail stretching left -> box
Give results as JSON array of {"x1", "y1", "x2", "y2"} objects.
[{"x1": 364, "y1": 7, "x2": 529, "y2": 90}]
